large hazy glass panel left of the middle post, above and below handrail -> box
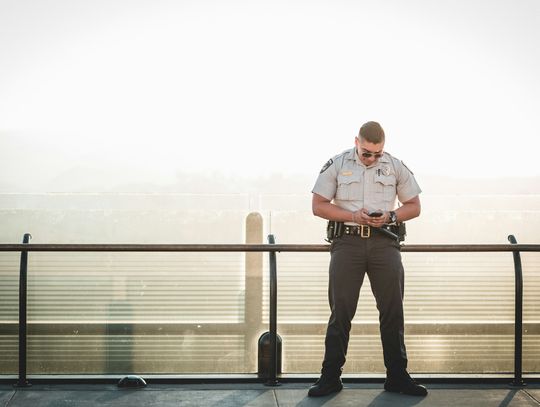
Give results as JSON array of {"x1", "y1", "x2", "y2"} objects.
[{"x1": 0, "y1": 193, "x2": 262, "y2": 374}]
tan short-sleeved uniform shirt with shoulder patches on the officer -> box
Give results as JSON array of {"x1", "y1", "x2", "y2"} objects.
[{"x1": 311, "y1": 148, "x2": 421, "y2": 217}]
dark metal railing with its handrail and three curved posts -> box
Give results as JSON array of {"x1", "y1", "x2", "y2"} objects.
[{"x1": 0, "y1": 233, "x2": 540, "y2": 387}]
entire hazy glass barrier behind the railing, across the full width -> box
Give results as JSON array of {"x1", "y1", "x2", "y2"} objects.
[{"x1": 0, "y1": 194, "x2": 540, "y2": 374}]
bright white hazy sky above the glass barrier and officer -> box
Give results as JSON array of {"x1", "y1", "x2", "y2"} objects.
[{"x1": 0, "y1": 0, "x2": 540, "y2": 190}]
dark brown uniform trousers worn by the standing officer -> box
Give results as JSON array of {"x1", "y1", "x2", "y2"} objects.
[{"x1": 322, "y1": 232, "x2": 407, "y2": 377}]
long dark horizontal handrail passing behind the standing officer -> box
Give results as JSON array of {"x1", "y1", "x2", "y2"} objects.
[{"x1": 0, "y1": 243, "x2": 540, "y2": 253}]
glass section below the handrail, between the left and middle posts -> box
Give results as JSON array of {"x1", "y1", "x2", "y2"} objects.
[{"x1": 19, "y1": 253, "x2": 251, "y2": 374}]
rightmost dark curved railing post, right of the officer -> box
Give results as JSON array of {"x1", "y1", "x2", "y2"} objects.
[{"x1": 508, "y1": 235, "x2": 525, "y2": 387}]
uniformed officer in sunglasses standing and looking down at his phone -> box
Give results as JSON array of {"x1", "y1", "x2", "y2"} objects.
[{"x1": 308, "y1": 121, "x2": 427, "y2": 397}]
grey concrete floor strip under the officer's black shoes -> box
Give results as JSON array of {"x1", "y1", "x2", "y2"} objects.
[{"x1": 0, "y1": 383, "x2": 540, "y2": 407}]
